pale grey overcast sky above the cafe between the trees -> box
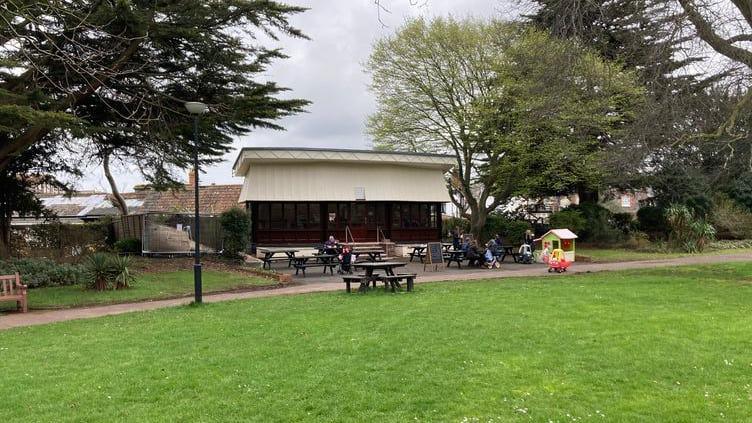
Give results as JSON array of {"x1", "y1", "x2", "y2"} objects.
[{"x1": 76, "y1": 0, "x2": 519, "y2": 192}]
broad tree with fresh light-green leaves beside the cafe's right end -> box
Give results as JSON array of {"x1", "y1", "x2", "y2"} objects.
[{"x1": 367, "y1": 19, "x2": 639, "y2": 237}]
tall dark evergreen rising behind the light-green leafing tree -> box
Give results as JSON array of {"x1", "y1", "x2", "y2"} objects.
[{"x1": 529, "y1": 0, "x2": 726, "y2": 195}]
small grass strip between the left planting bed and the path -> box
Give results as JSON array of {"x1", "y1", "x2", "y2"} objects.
[{"x1": 0, "y1": 270, "x2": 276, "y2": 310}]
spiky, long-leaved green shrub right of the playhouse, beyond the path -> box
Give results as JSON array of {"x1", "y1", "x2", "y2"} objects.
[{"x1": 666, "y1": 204, "x2": 715, "y2": 253}]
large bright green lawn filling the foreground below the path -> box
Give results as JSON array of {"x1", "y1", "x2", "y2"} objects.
[{"x1": 0, "y1": 263, "x2": 752, "y2": 422}]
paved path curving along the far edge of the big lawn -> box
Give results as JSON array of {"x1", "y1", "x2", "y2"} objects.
[{"x1": 0, "y1": 253, "x2": 752, "y2": 330}]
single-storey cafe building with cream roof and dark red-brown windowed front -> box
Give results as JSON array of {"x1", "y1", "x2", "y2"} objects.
[{"x1": 233, "y1": 148, "x2": 456, "y2": 245}]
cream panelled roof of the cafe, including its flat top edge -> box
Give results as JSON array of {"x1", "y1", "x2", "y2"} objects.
[{"x1": 234, "y1": 148, "x2": 454, "y2": 203}]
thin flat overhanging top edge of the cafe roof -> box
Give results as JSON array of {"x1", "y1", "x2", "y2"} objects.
[{"x1": 232, "y1": 147, "x2": 457, "y2": 176}]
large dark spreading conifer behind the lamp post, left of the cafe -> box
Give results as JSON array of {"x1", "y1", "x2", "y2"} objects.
[{"x1": 0, "y1": 0, "x2": 307, "y2": 248}]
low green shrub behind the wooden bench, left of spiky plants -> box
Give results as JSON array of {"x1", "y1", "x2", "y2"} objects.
[{"x1": 0, "y1": 258, "x2": 86, "y2": 288}]
